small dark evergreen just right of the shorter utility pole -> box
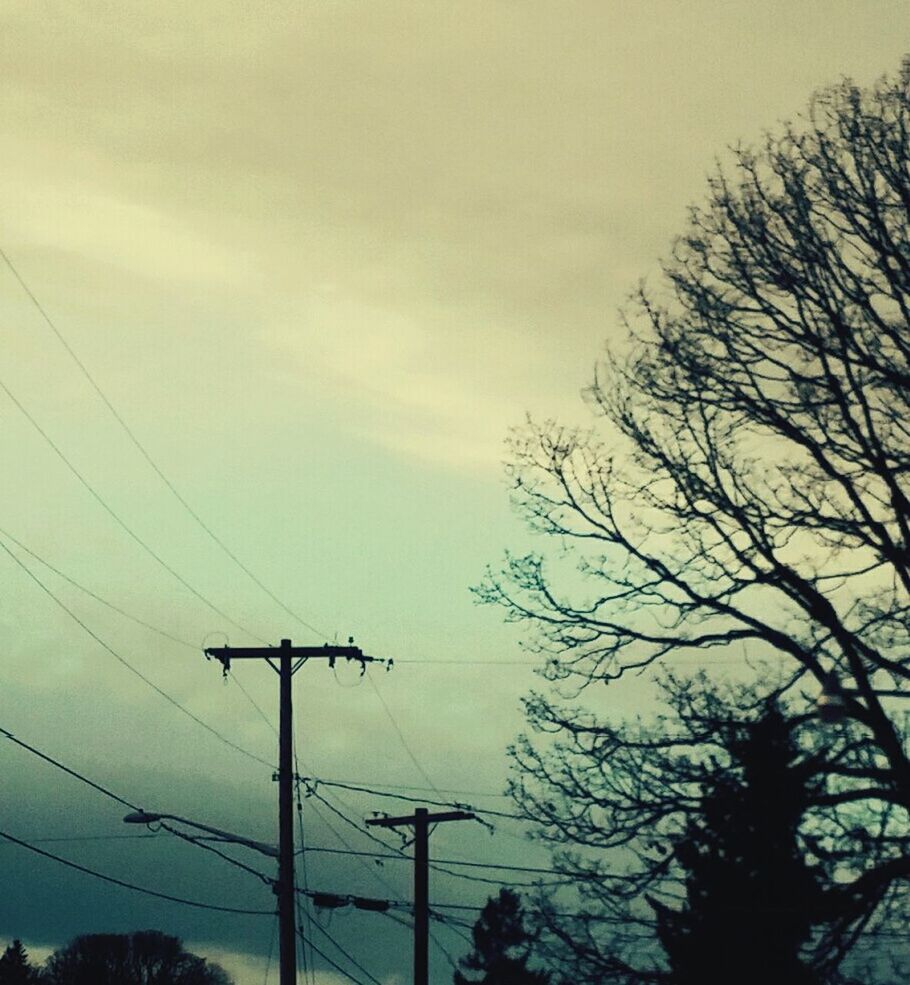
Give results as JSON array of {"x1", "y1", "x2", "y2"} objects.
[{"x1": 454, "y1": 889, "x2": 550, "y2": 985}]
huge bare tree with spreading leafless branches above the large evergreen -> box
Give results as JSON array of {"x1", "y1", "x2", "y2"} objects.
[{"x1": 478, "y1": 63, "x2": 910, "y2": 976}]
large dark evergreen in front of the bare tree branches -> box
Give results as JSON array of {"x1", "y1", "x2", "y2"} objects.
[{"x1": 652, "y1": 705, "x2": 824, "y2": 985}]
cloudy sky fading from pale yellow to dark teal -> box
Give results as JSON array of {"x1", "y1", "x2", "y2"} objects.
[{"x1": 0, "y1": 0, "x2": 910, "y2": 985}]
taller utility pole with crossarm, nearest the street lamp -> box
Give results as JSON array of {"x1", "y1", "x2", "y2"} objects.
[{"x1": 205, "y1": 640, "x2": 375, "y2": 985}]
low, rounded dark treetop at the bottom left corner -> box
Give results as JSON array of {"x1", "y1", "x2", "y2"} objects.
[{"x1": 44, "y1": 930, "x2": 231, "y2": 985}]
